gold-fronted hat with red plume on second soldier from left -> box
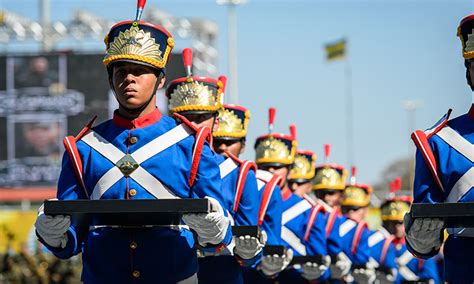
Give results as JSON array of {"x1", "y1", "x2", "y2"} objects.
[{"x1": 166, "y1": 48, "x2": 225, "y2": 113}]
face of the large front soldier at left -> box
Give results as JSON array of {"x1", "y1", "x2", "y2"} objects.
[{"x1": 112, "y1": 62, "x2": 164, "y2": 109}]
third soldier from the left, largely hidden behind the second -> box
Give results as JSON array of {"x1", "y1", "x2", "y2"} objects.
[{"x1": 213, "y1": 104, "x2": 291, "y2": 283}]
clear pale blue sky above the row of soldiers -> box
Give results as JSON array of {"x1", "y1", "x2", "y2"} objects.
[{"x1": 0, "y1": 0, "x2": 474, "y2": 184}]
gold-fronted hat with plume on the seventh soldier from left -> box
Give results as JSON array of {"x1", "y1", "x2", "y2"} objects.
[{"x1": 341, "y1": 167, "x2": 372, "y2": 208}]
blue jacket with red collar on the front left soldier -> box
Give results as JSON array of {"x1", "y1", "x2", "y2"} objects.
[{"x1": 39, "y1": 110, "x2": 232, "y2": 283}]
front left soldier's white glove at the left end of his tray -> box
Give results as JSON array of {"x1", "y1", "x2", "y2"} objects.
[{"x1": 35, "y1": 205, "x2": 71, "y2": 248}]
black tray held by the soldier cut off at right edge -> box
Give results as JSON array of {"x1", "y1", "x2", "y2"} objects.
[{"x1": 411, "y1": 202, "x2": 474, "y2": 228}]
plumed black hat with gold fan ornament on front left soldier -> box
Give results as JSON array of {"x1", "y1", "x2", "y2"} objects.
[{"x1": 103, "y1": 0, "x2": 174, "y2": 70}]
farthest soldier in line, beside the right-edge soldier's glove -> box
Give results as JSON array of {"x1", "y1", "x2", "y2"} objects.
[{"x1": 380, "y1": 195, "x2": 440, "y2": 283}]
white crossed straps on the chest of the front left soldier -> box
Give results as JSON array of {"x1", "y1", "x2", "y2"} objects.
[{"x1": 81, "y1": 124, "x2": 191, "y2": 199}]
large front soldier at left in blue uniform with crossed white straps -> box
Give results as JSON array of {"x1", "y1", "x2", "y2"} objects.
[{"x1": 31, "y1": 1, "x2": 232, "y2": 283}]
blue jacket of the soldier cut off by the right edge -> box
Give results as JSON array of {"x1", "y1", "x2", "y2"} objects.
[{"x1": 408, "y1": 106, "x2": 474, "y2": 283}]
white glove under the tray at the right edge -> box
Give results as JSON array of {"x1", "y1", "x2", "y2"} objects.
[{"x1": 404, "y1": 213, "x2": 444, "y2": 254}]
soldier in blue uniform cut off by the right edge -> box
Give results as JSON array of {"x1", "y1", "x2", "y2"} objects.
[{"x1": 405, "y1": 15, "x2": 474, "y2": 283}]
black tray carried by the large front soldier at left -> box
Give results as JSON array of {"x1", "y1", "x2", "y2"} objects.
[{"x1": 44, "y1": 199, "x2": 210, "y2": 226}]
